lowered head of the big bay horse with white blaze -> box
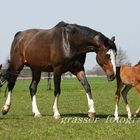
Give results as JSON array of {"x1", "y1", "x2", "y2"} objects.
[{"x1": 96, "y1": 37, "x2": 117, "y2": 81}]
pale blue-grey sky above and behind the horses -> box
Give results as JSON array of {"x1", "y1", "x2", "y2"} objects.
[{"x1": 0, "y1": 0, "x2": 140, "y2": 70}]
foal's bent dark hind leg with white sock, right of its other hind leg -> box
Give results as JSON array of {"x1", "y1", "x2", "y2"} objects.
[{"x1": 122, "y1": 86, "x2": 132, "y2": 119}]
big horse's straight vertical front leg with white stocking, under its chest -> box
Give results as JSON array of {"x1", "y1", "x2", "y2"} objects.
[{"x1": 53, "y1": 70, "x2": 61, "y2": 119}]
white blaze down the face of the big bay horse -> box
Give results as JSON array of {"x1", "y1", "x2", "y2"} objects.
[{"x1": 107, "y1": 49, "x2": 116, "y2": 75}]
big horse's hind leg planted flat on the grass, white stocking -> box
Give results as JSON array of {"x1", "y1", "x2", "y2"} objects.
[{"x1": 29, "y1": 70, "x2": 41, "y2": 117}]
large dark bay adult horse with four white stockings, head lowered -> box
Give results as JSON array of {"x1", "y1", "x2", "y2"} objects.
[{"x1": 0, "y1": 21, "x2": 117, "y2": 119}]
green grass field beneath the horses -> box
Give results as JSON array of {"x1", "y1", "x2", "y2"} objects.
[{"x1": 0, "y1": 78, "x2": 140, "y2": 140}]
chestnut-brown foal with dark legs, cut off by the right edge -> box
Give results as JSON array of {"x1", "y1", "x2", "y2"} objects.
[{"x1": 114, "y1": 62, "x2": 140, "y2": 120}]
